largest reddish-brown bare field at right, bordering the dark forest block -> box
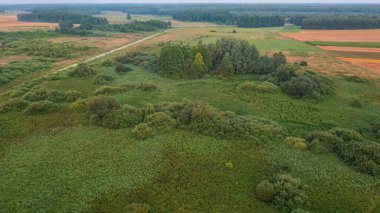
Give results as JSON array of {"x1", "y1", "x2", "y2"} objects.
[{"x1": 283, "y1": 29, "x2": 380, "y2": 42}]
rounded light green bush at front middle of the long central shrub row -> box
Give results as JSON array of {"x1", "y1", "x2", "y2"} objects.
[{"x1": 145, "y1": 112, "x2": 177, "y2": 132}]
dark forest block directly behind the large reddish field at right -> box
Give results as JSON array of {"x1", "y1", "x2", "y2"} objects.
[{"x1": 295, "y1": 15, "x2": 380, "y2": 30}]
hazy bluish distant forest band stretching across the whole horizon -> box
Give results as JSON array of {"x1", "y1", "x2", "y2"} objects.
[{"x1": 5, "y1": 4, "x2": 380, "y2": 29}]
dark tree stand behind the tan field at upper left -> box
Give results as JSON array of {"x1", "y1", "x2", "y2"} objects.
[{"x1": 17, "y1": 10, "x2": 108, "y2": 25}]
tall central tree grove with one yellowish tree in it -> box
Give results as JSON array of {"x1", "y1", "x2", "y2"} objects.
[{"x1": 158, "y1": 39, "x2": 286, "y2": 79}]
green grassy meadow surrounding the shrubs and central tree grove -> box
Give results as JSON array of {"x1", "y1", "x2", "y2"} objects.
[{"x1": 0, "y1": 13, "x2": 380, "y2": 213}]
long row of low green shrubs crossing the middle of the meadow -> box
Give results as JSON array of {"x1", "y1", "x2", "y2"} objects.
[{"x1": 87, "y1": 97, "x2": 284, "y2": 141}]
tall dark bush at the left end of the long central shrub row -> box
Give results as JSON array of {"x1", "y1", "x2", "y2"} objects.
[{"x1": 87, "y1": 96, "x2": 120, "y2": 126}]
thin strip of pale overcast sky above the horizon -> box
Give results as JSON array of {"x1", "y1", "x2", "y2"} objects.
[{"x1": 0, "y1": 0, "x2": 380, "y2": 4}]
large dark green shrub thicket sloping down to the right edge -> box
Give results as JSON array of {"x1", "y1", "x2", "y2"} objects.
[{"x1": 306, "y1": 128, "x2": 380, "y2": 176}]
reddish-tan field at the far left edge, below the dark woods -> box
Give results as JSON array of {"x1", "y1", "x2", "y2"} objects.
[{"x1": 0, "y1": 14, "x2": 58, "y2": 31}]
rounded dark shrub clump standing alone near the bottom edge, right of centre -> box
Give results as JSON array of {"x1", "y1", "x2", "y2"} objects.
[{"x1": 256, "y1": 174, "x2": 310, "y2": 210}]
